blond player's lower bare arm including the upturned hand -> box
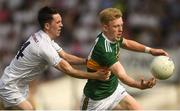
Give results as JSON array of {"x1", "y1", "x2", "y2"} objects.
[{"x1": 110, "y1": 61, "x2": 156, "y2": 89}]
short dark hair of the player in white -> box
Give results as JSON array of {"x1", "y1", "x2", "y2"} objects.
[{"x1": 38, "y1": 6, "x2": 59, "y2": 29}]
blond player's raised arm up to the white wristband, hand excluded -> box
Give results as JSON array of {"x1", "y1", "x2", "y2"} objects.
[{"x1": 123, "y1": 38, "x2": 151, "y2": 53}]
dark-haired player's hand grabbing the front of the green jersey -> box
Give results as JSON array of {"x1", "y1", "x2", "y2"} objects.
[{"x1": 95, "y1": 69, "x2": 111, "y2": 81}]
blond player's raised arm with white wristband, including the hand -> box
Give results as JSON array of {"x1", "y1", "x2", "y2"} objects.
[{"x1": 123, "y1": 39, "x2": 168, "y2": 56}]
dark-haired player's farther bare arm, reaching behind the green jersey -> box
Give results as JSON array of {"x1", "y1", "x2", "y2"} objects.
[{"x1": 59, "y1": 50, "x2": 86, "y2": 65}]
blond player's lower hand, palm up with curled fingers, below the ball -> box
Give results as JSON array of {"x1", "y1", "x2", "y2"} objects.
[{"x1": 141, "y1": 77, "x2": 156, "y2": 89}]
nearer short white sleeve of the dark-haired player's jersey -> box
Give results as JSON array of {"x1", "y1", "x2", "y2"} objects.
[{"x1": 40, "y1": 41, "x2": 62, "y2": 66}]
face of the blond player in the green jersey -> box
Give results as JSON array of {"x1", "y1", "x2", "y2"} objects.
[{"x1": 104, "y1": 17, "x2": 123, "y2": 41}]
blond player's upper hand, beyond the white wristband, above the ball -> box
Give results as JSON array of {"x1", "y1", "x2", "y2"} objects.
[{"x1": 150, "y1": 48, "x2": 169, "y2": 56}]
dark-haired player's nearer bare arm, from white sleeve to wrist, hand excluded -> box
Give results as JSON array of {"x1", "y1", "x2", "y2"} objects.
[{"x1": 55, "y1": 60, "x2": 97, "y2": 79}]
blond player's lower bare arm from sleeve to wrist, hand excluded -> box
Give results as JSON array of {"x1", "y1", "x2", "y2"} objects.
[{"x1": 110, "y1": 61, "x2": 141, "y2": 89}]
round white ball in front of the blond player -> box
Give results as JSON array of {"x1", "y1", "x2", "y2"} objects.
[{"x1": 151, "y1": 56, "x2": 175, "y2": 80}]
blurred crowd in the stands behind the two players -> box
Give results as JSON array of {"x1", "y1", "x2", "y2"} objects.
[{"x1": 0, "y1": 0, "x2": 180, "y2": 79}]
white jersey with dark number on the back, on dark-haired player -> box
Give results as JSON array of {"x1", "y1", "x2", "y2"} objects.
[{"x1": 0, "y1": 30, "x2": 62, "y2": 106}]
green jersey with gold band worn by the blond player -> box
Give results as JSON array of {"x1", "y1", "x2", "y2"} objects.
[{"x1": 84, "y1": 33, "x2": 123, "y2": 100}]
